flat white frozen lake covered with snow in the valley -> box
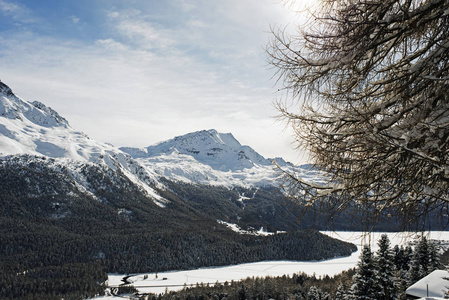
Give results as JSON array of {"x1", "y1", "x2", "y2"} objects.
[{"x1": 94, "y1": 231, "x2": 449, "y2": 299}]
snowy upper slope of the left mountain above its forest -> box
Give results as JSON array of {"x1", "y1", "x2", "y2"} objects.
[{"x1": 0, "y1": 81, "x2": 159, "y2": 204}]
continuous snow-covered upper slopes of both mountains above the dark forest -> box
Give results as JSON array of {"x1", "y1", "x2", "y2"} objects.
[{"x1": 0, "y1": 81, "x2": 312, "y2": 194}]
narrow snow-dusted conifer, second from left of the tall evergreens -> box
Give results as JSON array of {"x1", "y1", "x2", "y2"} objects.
[{"x1": 377, "y1": 234, "x2": 395, "y2": 300}]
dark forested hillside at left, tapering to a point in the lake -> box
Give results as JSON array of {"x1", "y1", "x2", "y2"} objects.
[{"x1": 0, "y1": 156, "x2": 355, "y2": 299}]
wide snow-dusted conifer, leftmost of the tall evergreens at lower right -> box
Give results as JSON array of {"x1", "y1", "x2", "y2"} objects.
[{"x1": 350, "y1": 245, "x2": 380, "y2": 300}]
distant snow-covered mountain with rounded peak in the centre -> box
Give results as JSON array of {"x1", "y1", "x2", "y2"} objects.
[{"x1": 120, "y1": 129, "x2": 293, "y2": 186}]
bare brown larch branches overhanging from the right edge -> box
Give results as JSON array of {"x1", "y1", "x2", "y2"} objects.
[{"x1": 267, "y1": 0, "x2": 449, "y2": 228}]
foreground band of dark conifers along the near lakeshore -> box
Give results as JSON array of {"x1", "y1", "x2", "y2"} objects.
[{"x1": 140, "y1": 235, "x2": 443, "y2": 300}]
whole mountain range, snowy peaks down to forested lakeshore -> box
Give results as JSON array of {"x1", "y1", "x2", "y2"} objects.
[{"x1": 0, "y1": 82, "x2": 356, "y2": 299}]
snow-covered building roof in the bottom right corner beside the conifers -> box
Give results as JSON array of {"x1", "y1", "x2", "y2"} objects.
[{"x1": 405, "y1": 270, "x2": 449, "y2": 300}]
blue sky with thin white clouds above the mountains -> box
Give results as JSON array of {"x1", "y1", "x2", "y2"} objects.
[{"x1": 0, "y1": 0, "x2": 313, "y2": 164}]
